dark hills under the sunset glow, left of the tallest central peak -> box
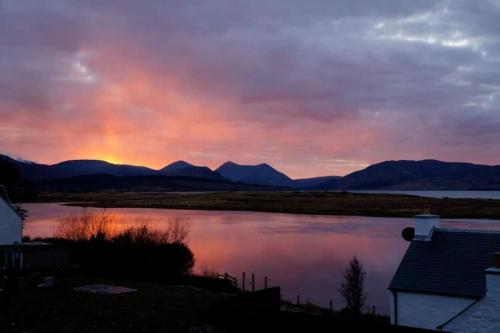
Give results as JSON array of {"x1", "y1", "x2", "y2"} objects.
[{"x1": 2, "y1": 155, "x2": 266, "y2": 191}]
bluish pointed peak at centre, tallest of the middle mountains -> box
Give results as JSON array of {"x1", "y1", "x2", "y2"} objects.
[{"x1": 215, "y1": 162, "x2": 293, "y2": 186}]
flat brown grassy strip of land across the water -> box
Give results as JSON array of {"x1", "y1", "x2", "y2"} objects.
[{"x1": 33, "y1": 192, "x2": 500, "y2": 219}]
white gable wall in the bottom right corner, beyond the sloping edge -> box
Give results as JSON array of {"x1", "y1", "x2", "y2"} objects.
[{"x1": 444, "y1": 269, "x2": 500, "y2": 333}]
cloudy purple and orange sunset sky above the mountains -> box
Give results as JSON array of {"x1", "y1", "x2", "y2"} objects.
[{"x1": 0, "y1": 0, "x2": 500, "y2": 178}]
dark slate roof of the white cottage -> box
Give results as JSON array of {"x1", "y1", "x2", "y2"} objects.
[{"x1": 389, "y1": 228, "x2": 500, "y2": 298}]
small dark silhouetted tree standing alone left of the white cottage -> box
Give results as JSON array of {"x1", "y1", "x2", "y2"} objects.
[{"x1": 339, "y1": 256, "x2": 366, "y2": 315}]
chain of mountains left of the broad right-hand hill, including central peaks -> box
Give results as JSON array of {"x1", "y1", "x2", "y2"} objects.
[{"x1": 4, "y1": 156, "x2": 331, "y2": 190}]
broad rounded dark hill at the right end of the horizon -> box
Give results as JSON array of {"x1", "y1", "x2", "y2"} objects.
[{"x1": 315, "y1": 160, "x2": 500, "y2": 190}]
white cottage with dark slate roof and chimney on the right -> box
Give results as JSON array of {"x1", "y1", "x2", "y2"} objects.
[{"x1": 389, "y1": 214, "x2": 500, "y2": 333}]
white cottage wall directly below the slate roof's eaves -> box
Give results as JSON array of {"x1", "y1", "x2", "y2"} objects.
[{"x1": 391, "y1": 292, "x2": 474, "y2": 329}]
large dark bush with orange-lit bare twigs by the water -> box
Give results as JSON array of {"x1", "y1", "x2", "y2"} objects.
[{"x1": 46, "y1": 210, "x2": 194, "y2": 281}]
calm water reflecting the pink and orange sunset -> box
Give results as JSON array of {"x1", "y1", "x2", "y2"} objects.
[{"x1": 19, "y1": 204, "x2": 500, "y2": 314}]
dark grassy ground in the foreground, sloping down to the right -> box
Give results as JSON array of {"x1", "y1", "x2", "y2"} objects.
[{"x1": 0, "y1": 277, "x2": 438, "y2": 333}]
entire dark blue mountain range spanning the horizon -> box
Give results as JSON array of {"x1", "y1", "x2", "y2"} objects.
[{"x1": 5, "y1": 156, "x2": 500, "y2": 191}]
